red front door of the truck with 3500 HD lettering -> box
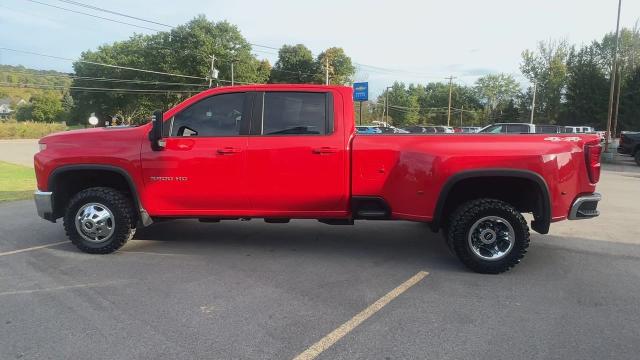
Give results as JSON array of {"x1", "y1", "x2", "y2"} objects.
[{"x1": 141, "y1": 93, "x2": 253, "y2": 215}]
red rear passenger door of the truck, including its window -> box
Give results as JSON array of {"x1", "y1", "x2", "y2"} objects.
[{"x1": 247, "y1": 90, "x2": 349, "y2": 217}]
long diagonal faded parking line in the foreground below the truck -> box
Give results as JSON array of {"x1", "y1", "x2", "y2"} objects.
[{"x1": 293, "y1": 271, "x2": 429, "y2": 360}]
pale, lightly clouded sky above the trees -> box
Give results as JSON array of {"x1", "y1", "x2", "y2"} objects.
[{"x1": 0, "y1": 0, "x2": 640, "y2": 94}]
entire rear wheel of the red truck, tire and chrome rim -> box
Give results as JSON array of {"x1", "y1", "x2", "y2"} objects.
[{"x1": 447, "y1": 199, "x2": 529, "y2": 274}]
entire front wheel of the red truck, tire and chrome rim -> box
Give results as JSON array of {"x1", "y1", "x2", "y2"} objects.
[{"x1": 64, "y1": 187, "x2": 136, "y2": 254}]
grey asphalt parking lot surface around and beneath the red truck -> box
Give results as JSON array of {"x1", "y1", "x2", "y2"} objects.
[{"x1": 0, "y1": 165, "x2": 640, "y2": 359}]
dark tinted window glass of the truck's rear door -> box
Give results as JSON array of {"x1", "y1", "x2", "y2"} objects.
[{"x1": 262, "y1": 92, "x2": 333, "y2": 135}]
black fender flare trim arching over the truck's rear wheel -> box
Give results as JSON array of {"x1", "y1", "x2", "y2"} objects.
[{"x1": 431, "y1": 168, "x2": 551, "y2": 234}]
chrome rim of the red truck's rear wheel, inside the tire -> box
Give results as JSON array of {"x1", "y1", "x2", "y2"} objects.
[{"x1": 468, "y1": 216, "x2": 516, "y2": 261}]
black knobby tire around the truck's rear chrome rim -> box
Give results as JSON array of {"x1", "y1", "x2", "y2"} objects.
[{"x1": 446, "y1": 199, "x2": 529, "y2": 274}]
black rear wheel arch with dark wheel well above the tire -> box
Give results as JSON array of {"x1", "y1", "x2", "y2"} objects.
[{"x1": 431, "y1": 168, "x2": 551, "y2": 234}]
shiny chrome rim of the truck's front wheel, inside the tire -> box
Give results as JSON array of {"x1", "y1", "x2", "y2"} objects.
[{"x1": 76, "y1": 203, "x2": 115, "y2": 243}]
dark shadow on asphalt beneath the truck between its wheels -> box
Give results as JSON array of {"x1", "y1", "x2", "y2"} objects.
[{"x1": 134, "y1": 219, "x2": 467, "y2": 272}]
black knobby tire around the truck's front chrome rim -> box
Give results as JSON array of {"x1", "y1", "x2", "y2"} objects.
[{"x1": 64, "y1": 187, "x2": 136, "y2": 254}]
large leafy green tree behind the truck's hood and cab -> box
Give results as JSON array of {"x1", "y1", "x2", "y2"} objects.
[{"x1": 73, "y1": 15, "x2": 270, "y2": 123}]
